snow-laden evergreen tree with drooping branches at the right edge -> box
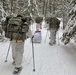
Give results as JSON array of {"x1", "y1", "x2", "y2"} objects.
[{"x1": 62, "y1": 0, "x2": 76, "y2": 44}]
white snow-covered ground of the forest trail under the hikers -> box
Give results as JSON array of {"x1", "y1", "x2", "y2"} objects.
[{"x1": 0, "y1": 20, "x2": 76, "y2": 75}]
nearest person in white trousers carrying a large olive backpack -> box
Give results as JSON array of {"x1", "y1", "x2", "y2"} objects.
[{"x1": 2, "y1": 15, "x2": 32, "y2": 74}]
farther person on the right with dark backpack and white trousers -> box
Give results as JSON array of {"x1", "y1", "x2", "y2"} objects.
[{"x1": 47, "y1": 17, "x2": 60, "y2": 45}]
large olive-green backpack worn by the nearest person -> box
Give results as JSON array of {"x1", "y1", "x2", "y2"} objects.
[{"x1": 5, "y1": 17, "x2": 29, "y2": 41}]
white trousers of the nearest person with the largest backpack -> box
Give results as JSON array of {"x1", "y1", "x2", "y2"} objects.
[{"x1": 11, "y1": 41, "x2": 24, "y2": 67}]
